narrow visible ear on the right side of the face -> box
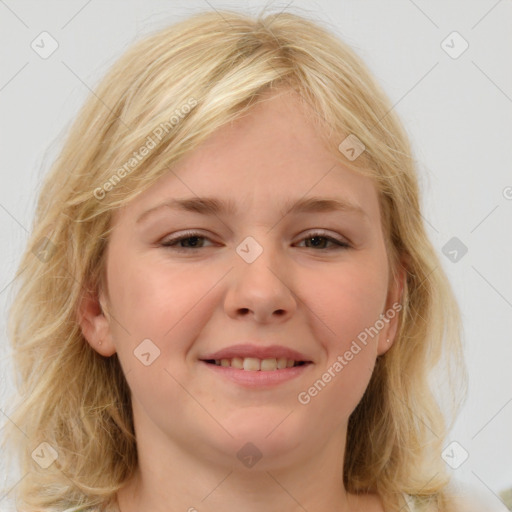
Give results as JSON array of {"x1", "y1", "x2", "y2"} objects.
[{"x1": 377, "y1": 264, "x2": 407, "y2": 356}]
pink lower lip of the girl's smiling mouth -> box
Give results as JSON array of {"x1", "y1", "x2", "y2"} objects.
[{"x1": 201, "y1": 361, "x2": 313, "y2": 388}]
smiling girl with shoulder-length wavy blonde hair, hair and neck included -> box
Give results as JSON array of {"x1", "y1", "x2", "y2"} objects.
[{"x1": 3, "y1": 11, "x2": 480, "y2": 512}]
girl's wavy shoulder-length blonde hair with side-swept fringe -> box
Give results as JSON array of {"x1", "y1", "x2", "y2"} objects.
[{"x1": 2, "y1": 10, "x2": 466, "y2": 512}]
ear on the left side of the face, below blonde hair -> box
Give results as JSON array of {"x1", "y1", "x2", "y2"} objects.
[{"x1": 78, "y1": 284, "x2": 116, "y2": 357}]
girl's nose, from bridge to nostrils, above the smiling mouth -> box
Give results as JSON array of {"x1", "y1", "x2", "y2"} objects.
[{"x1": 224, "y1": 240, "x2": 297, "y2": 323}]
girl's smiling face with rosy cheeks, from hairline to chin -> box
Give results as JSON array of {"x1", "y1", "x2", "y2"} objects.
[{"x1": 84, "y1": 93, "x2": 399, "y2": 468}]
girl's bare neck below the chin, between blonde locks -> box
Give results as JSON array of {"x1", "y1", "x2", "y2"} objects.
[{"x1": 118, "y1": 418, "x2": 356, "y2": 512}]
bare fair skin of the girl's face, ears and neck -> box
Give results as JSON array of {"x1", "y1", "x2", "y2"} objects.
[{"x1": 81, "y1": 91, "x2": 403, "y2": 512}]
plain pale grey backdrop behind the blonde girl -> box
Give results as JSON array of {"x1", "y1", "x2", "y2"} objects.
[{"x1": 0, "y1": 0, "x2": 512, "y2": 510}]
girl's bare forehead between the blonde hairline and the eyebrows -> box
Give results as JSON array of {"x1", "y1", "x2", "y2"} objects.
[{"x1": 115, "y1": 91, "x2": 379, "y2": 226}]
